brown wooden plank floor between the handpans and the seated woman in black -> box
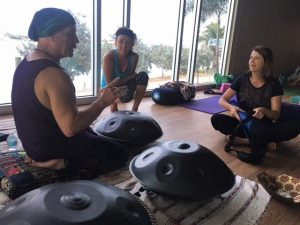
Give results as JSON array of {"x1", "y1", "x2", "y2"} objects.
[{"x1": 0, "y1": 94, "x2": 300, "y2": 225}]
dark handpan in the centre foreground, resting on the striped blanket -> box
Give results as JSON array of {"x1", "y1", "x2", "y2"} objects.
[{"x1": 129, "y1": 140, "x2": 235, "y2": 200}]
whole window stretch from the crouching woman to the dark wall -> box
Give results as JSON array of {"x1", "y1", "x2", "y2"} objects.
[{"x1": 129, "y1": 0, "x2": 233, "y2": 89}]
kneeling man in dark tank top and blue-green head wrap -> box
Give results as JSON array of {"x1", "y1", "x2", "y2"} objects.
[{"x1": 12, "y1": 8, "x2": 128, "y2": 173}]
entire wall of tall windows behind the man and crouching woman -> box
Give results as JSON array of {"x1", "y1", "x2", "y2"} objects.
[{"x1": 0, "y1": 0, "x2": 235, "y2": 113}]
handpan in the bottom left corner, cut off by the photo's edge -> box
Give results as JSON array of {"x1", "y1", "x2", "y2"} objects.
[{"x1": 0, "y1": 180, "x2": 155, "y2": 225}]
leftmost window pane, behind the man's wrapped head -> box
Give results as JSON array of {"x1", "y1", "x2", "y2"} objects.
[{"x1": 0, "y1": 0, "x2": 93, "y2": 104}]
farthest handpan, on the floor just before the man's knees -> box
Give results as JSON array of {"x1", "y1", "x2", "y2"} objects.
[{"x1": 94, "y1": 110, "x2": 163, "y2": 144}]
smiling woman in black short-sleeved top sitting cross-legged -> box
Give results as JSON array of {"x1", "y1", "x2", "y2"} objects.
[{"x1": 211, "y1": 46, "x2": 300, "y2": 164}]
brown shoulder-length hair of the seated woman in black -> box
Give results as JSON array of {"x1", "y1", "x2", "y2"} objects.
[{"x1": 252, "y1": 46, "x2": 273, "y2": 80}]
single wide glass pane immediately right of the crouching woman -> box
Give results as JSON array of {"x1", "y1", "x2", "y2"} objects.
[{"x1": 130, "y1": 0, "x2": 179, "y2": 89}]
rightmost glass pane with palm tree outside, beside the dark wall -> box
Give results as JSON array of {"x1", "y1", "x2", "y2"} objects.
[{"x1": 192, "y1": 0, "x2": 231, "y2": 83}]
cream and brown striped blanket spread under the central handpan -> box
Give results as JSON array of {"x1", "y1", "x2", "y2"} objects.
[{"x1": 0, "y1": 120, "x2": 270, "y2": 225}]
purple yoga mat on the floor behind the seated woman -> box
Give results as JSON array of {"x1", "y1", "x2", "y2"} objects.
[{"x1": 180, "y1": 95, "x2": 237, "y2": 114}]
